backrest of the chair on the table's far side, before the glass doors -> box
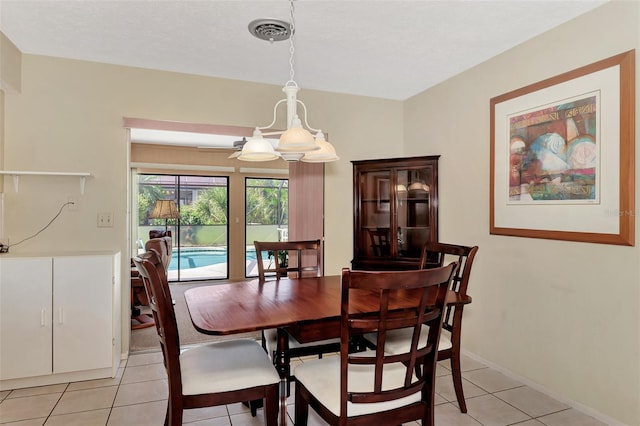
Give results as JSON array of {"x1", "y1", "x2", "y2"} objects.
[{"x1": 253, "y1": 240, "x2": 322, "y2": 281}]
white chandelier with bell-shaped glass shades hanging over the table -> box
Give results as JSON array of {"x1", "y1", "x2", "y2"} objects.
[{"x1": 231, "y1": 0, "x2": 339, "y2": 163}]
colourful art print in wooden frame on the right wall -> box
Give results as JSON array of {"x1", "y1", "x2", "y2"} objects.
[{"x1": 489, "y1": 50, "x2": 635, "y2": 246}]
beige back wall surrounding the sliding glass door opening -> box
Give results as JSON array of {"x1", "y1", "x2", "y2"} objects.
[{"x1": 4, "y1": 51, "x2": 402, "y2": 351}]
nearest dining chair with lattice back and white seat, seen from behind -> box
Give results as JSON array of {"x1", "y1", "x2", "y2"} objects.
[{"x1": 295, "y1": 263, "x2": 456, "y2": 426}]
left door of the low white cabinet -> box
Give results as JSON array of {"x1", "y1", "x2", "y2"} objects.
[{"x1": 0, "y1": 258, "x2": 52, "y2": 380}]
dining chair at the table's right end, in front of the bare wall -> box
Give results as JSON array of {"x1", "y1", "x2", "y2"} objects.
[{"x1": 365, "y1": 241, "x2": 478, "y2": 413}]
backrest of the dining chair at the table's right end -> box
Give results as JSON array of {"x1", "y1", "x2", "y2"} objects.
[{"x1": 420, "y1": 241, "x2": 478, "y2": 331}]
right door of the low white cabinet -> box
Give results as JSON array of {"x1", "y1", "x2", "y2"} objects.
[{"x1": 53, "y1": 255, "x2": 114, "y2": 373}]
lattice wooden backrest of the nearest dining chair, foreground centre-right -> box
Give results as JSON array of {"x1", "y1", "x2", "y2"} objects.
[{"x1": 340, "y1": 263, "x2": 456, "y2": 413}]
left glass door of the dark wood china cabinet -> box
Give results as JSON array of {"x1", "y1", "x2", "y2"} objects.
[{"x1": 357, "y1": 170, "x2": 394, "y2": 258}]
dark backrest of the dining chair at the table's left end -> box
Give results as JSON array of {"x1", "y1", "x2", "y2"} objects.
[{"x1": 133, "y1": 251, "x2": 182, "y2": 395}]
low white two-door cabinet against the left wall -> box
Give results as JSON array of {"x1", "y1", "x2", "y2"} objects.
[{"x1": 0, "y1": 253, "x2": 120, "y2": 389}]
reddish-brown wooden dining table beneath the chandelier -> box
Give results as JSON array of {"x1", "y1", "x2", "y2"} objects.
[{"x1": 184, "y1": 275, "x2": 471, "y2": 425}]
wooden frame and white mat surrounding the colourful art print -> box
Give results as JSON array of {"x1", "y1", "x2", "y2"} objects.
[{"x1": 489, "y1": 50, "x2": 635, "y2": 246}]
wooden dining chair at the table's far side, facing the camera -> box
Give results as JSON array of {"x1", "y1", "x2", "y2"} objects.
[{"x1": 253, "y1": 240, "x2": 340, "y2": 394}]
